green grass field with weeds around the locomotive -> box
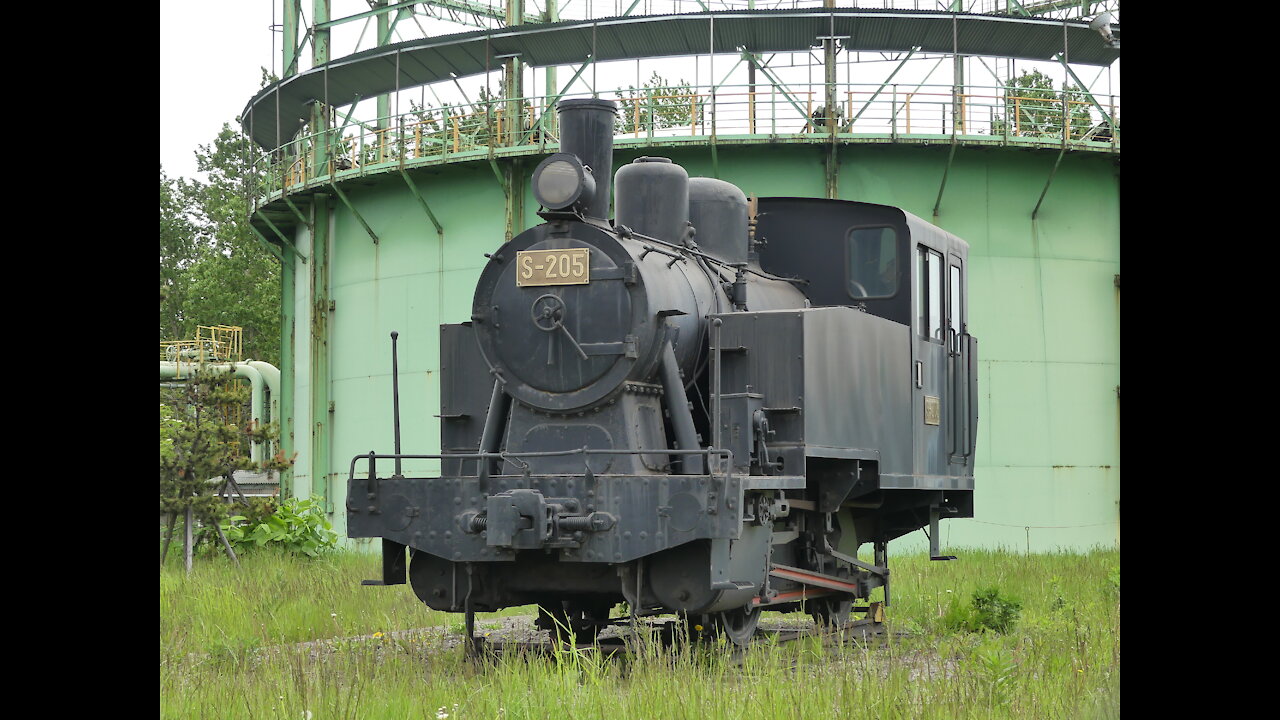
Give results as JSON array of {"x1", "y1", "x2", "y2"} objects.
[{"x1": 160, "y1": 550, "x2": 1120, "y2": 720}]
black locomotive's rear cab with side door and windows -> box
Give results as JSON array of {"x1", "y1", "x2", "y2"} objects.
[{"x1": 758, "y1": 197, "x2": 978, "y2": 557}]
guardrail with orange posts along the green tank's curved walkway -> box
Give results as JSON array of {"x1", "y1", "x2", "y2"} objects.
[{"x1": 253, "y1": 83, "x2": 1120, "y2": 206}]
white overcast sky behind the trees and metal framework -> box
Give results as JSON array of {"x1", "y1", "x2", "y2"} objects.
[{"x1": 160, "y1": 0, "x2": 1120, "y2": 177}]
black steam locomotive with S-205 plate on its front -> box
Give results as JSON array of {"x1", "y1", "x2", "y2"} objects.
[{"x1": 347, "y1": 100, "x2": 978, "y2": 643}]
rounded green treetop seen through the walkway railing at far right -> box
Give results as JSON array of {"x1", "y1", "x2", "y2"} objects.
[{"x1": 991, "y1": 70, "x2": 1093, "y2": 140}]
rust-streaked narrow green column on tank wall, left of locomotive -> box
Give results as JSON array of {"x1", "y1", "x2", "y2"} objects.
[{"x1": 310, "y1": 193, "x2": 334, "y2": 512}]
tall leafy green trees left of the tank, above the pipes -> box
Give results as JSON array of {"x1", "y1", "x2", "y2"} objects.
[{"x1": 160, "y1": 124, "x2": 280, "y2": 364}]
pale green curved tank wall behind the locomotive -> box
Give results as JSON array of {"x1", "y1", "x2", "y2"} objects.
[{"x1": 285, "y1": 145, "x2": 1120, "y2": 552}]
